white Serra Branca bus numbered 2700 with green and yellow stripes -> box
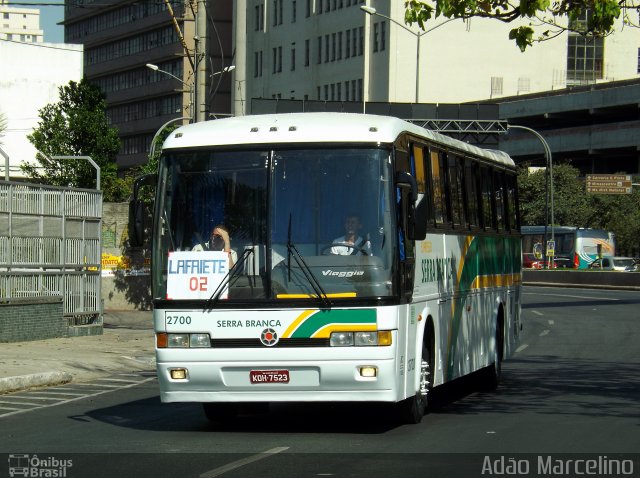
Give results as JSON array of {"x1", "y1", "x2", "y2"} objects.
[{"x1": 130, "y1": 113, "x2": 521, "y2": 423}]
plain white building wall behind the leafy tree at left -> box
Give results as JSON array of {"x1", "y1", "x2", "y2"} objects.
[{"x1": 0, "y1": 41, "x2": 83, "y2": 179}]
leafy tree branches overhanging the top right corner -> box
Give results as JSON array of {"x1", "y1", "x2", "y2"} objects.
[{"x1": 405, "y1": 0, "x2": 640, "y2": 51}]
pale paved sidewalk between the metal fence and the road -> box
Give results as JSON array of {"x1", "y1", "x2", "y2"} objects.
[{"x1": 0, "y1": 311, "x2": 155, "y2": 394}]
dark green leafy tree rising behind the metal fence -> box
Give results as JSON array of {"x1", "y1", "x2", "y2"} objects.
[{"x1": 21, "y1": 79, "x2": 130, "y2": 201}]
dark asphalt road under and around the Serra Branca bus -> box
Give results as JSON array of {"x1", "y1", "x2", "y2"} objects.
[{"x1": 0, "y1": 287, "x2": 640, "y2": 478}]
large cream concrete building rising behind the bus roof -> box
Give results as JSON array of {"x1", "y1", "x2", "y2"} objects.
[{"x1": 234, "y1": 0, "x2": 640, "y2": 114}]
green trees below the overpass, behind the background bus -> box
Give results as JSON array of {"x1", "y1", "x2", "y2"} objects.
[{"x1": 518, "y1": 164, "x2": 640, "y2": 254}]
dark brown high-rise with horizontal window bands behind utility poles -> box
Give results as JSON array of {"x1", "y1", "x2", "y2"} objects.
[{"x1": 64, "y1": 0, "x2": 233, "y2": 170}]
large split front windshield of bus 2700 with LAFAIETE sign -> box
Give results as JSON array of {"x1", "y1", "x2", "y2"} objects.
[{"x1": 152, "y1": 147, "x2": 397, "y2": 305}]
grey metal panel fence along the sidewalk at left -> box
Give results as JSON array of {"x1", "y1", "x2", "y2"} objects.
[{"x1": 0, "y1": 181, "x2": 102, "y2": 325}]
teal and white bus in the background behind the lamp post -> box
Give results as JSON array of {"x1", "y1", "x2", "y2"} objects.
[{"x1": 521, "y1": 226, "x2": 615, "y2": 269}]
